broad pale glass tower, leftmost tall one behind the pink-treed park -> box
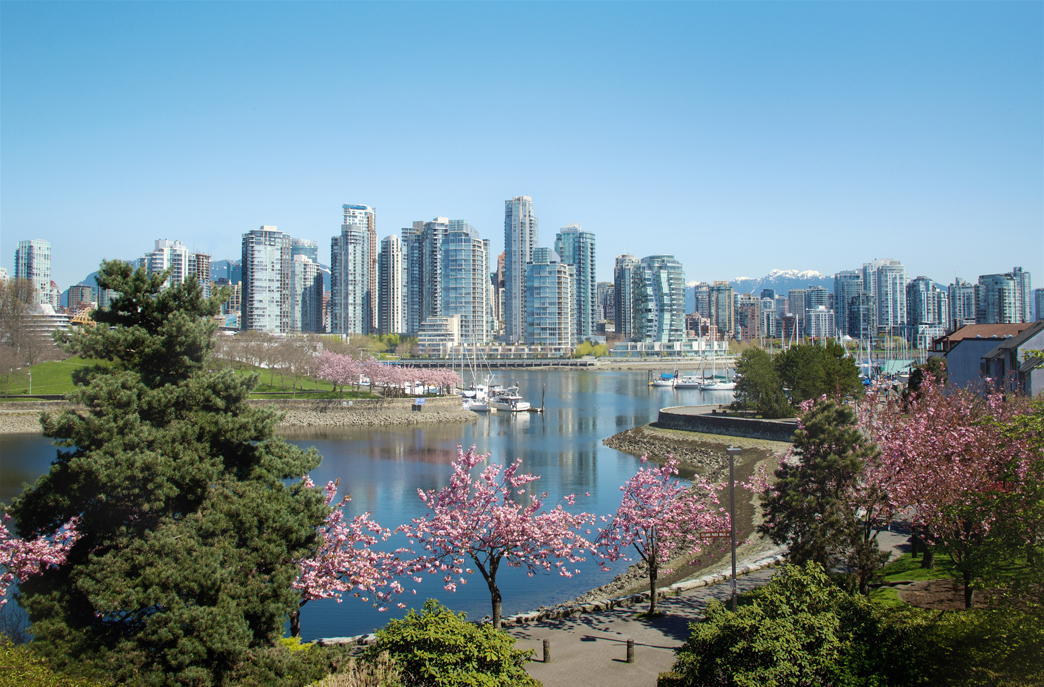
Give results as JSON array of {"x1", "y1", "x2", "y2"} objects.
[{"x1": 239, "y1": 224, "x2": 290, "y2": 333}]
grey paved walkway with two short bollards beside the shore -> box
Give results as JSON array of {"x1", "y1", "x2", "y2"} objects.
[{"x1": 507, "y1": 531, "x2": 907, "y2": 687}]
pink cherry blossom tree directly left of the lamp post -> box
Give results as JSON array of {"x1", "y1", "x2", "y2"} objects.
[{"x1": 595, "y1": 455, "x2": 729, "y2": 613}]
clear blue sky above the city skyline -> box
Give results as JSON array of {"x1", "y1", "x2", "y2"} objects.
[{"x1": 0, "y1": 0, "x2": 1044, "y2": 289}]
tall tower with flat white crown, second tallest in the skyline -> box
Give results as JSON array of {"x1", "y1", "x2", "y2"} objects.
[{"x1": 329, "y1": 205, "x2": 377, "y2": 334}]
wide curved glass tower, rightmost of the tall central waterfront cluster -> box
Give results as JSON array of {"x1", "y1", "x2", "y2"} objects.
[{"x1": 632, "y1": 255, "x2": 689, "y2": 344}]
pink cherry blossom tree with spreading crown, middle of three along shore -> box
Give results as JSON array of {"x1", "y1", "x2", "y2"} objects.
[{"x1": 398, "y1": 446, "x2": 593, "y2": 629}]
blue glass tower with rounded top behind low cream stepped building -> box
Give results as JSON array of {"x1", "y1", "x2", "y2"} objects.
[{"x1": 433, "y1": 220, "x2": 491, "y2": 345}]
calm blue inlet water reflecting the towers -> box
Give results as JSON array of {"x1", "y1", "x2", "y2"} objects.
[{"x1": 0, "y1": 371, "x2": 732, "y2": 640}]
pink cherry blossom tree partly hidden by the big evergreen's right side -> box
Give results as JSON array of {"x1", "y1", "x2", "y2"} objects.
[{"x1": 290, "y1": 479, "x2": 406, "y2": 637}]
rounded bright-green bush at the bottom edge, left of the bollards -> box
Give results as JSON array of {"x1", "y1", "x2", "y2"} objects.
[{"x1": 363, "y1": 599, "x2": 540, "y2": 687}]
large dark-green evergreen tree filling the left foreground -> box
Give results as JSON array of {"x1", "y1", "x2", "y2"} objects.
[{"x1": 10, "y1": 261, "x2": 328, "y2": 685}]
